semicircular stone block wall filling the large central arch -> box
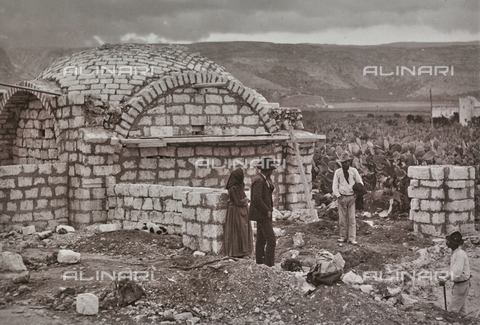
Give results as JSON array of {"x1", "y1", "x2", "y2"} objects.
[{"x1": 129, "y1": 87, "x2": 267, "y2": 138}]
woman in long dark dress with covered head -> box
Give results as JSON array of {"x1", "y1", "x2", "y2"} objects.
[{"x1": 224, "y1": 167, "x2": 253, "y2": 257}]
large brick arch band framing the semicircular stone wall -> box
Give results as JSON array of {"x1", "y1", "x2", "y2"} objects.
[{"x1": 115, "y1": 72, "x2": 279, "y2": 138}]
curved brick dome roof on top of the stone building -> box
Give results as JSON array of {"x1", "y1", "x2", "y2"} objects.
[{"x1": 36, "y1": 44, "x2": 235, "y2": 102}]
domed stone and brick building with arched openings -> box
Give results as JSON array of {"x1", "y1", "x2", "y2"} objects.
[{"x1": 0, "y1": 44, "x2": 324, "y2": 253}]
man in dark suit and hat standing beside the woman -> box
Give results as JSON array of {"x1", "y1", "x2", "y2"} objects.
[{"x1": 249, "y1": 158, "x2": 277, "y2": 266}]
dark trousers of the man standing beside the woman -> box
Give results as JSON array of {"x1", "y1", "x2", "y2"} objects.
[{"x1": 255, "y1": 219, "x2": 277, "y2": 266}]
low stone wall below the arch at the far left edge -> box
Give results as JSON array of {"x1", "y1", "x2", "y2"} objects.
[{"x1": 0, "y1": 163, "x2": 68, "y2": 231}]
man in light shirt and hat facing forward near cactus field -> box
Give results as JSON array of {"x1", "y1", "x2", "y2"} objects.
[{"x1": 332, "y1": 151, "x2": 363, "y2": 245}]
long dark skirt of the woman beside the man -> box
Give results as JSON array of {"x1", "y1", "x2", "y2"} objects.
[{"x1": 224, "y1": 203, "x2": 253, "y2": 257}]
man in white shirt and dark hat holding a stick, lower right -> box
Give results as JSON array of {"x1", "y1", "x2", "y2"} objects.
[{"x1": 439, "y1": 231, "x2": 471, "y2": 315}]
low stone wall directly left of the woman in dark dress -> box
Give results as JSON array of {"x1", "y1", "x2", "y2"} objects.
[{"x1": 108, "y1": 184, "x2": 228, "y2": 254}]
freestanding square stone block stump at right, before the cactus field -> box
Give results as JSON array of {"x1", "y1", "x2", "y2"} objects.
[{"x1": 408, "y1": 165, "x2": 476, "y2": 236}]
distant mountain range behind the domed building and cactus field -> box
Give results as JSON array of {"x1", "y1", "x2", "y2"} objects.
[{"x1": 0, "y1": 42, "x2": 480, "y2": 107}]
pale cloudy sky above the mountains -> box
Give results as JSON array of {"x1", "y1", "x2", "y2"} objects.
[{"x1": 0, "y1": 0, "x2": 480, "y2": 48}]
